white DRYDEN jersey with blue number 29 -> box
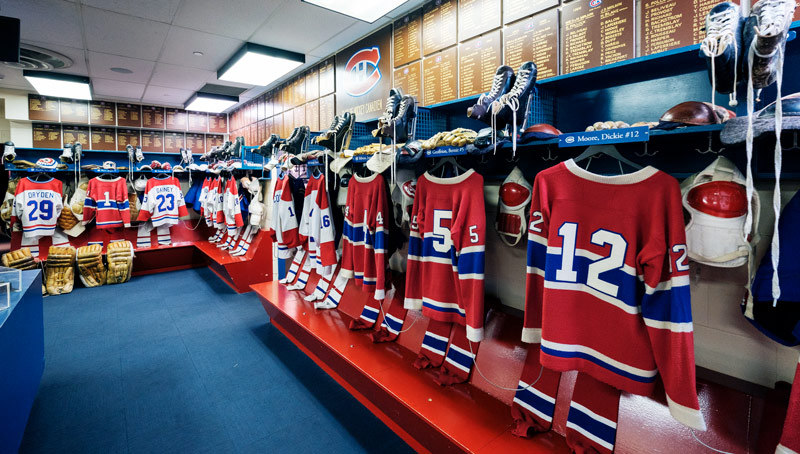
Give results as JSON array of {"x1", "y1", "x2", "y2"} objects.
[{"x1": 11, "y1": 178, "x2": 64, "y2": 239}]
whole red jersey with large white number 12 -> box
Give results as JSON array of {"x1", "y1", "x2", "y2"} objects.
[{"x1": 522, "y1": 160, "x2": 705, "y2": 430}]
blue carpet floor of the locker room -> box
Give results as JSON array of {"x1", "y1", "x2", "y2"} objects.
[{"x1": 21, "y1": 268, "x2": 412, "y2": 453}]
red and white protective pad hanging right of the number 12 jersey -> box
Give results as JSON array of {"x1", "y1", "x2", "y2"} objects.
[{"x1": 681, "y1": 157, "x2": 759, "y2": 268}]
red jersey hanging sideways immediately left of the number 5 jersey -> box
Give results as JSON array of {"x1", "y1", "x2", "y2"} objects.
[{"x1": 340, "y1": 173, "x2": 392, "y2": 300}]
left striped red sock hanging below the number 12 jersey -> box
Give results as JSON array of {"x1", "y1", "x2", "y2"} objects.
[{"x1": 511, "y1": 344, "x2": 561, "y2": 437}]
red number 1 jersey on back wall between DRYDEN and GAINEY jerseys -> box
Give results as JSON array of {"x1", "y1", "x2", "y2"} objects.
[{"x1": 83, "y1": 177, "x2": 131, "y2": 229}]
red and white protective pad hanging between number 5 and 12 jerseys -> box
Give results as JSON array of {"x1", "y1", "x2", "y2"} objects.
[{"x1": 494, "y1": 167, "x2": 533, "y2": 246}]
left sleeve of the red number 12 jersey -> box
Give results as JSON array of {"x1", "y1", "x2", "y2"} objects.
[{"x1": 522, "y1": 178, "x2": 550, "y2": 343}]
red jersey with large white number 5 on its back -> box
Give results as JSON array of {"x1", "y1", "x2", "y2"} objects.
[{"x1": 405, "y1": 170, "x2": 486, "y2": 342}]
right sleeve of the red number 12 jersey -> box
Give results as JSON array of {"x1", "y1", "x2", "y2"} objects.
[{"x1": 640, "y1": 181, "x2": 706, "y2": 430}]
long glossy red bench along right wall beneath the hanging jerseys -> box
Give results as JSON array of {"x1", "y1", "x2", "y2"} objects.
[{"x1": 252, "y1": 277, "x2": 787, "y2": 454}]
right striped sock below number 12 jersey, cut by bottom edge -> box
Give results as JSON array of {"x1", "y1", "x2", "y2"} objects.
[{"x1": 566, "y1": 373, "x2": 620, "y2": 454}]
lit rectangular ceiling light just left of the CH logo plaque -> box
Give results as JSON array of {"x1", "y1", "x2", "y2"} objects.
[{"x1": 217, "y1": 43, "x2": 306, "y2": 86}]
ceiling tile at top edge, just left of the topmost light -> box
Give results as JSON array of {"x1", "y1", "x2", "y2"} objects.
[{"x1": 173, "y1": 0, "x2": 285, "y2": 40}]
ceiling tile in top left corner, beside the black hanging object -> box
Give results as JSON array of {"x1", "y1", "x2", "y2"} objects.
[{"x1": 1, "y1": 0, "x2": 83, "y2": 48}]
